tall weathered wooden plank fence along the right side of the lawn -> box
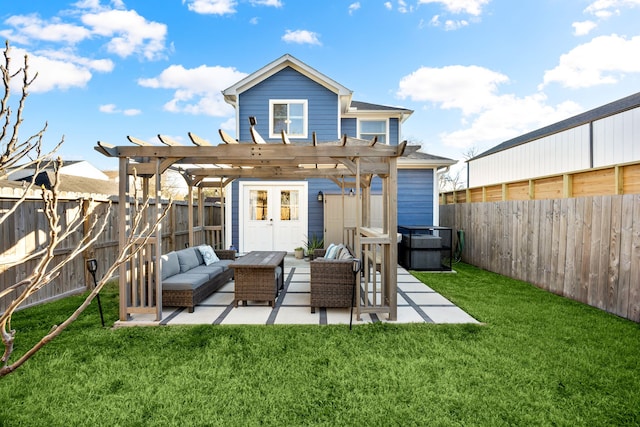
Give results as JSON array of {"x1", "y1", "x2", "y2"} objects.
[{"x1": 440, "y1": 194, "x2": 640, "y2": 322}]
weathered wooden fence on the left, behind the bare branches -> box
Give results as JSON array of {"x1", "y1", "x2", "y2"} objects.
[{"x1": 0, "y1": 191, "x2": 222, "y2": 312}]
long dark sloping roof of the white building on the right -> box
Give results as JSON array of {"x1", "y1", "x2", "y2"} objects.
[{"x1": 469, "y1": 92, "x2": 640, "y2": 161}]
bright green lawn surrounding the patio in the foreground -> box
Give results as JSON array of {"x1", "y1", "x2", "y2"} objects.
[{"x1": 0, "y1": 264, "x2": 640, "y2": 426}]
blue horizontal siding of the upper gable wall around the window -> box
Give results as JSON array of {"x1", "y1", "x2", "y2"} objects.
[{"x1": 238, "y1": 67, "x2": 338, "y2": 141}]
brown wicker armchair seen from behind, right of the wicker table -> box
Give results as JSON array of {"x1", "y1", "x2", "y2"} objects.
[{"x1": 309, "y1": 249, "x2": 360, "y2": 313}]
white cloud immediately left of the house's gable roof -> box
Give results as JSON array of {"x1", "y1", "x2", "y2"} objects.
[{"x1": 138, "y1": 65, "x2": 246, "y2": 117}]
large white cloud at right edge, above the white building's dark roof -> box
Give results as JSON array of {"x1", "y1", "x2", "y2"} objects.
[{"x1": 541, "y1": 34, "x2": 640, "y2": 88}]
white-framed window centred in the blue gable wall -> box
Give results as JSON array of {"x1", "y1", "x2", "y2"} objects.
[{"x1": 269, "y1": 99, "x2": 307, "y2": 138}]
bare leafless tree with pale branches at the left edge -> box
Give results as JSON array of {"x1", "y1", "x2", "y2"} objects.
[{"x1": 0, "y1": 42, "x2": 171, "y2": 377}]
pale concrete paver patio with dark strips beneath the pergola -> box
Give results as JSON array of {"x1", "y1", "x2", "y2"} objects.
[{"x1": 115, "y1": 255, "x2": 478, "y2": 327}]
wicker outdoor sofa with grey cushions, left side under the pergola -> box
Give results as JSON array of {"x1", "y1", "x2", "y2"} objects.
[{"x1": 162, "y1": 245, "x2": 236, "y2": 313}]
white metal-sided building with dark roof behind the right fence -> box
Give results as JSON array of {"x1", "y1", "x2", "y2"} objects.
[{"x1": 467, "y1": 92, "x2": 640, "y2": 188}]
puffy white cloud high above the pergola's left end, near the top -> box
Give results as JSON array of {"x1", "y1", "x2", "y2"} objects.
[{"x1": 82, "y1": 10, "x2": 167, "y2": 60}]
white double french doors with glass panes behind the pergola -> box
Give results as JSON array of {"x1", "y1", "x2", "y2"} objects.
[{"x1": 238, "y1": 182, "x2": 308, "y2": 252}]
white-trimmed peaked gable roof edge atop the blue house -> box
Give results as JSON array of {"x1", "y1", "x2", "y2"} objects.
[{"x1": 222, "y1": 53, "x2": 353, "y2": 111}]
